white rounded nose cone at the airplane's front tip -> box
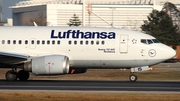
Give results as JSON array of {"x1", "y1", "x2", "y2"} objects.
[{"x1": 162, "y1": 45, "x2": 176, "y2": 59}]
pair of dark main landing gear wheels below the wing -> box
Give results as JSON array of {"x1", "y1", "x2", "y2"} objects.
[{"x1": 5, "y1": 69, "x2": 29, "y2": 81}]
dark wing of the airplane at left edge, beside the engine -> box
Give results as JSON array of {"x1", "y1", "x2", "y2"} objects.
[{"x1": 0, "y1": 52, "x2": 30, "y2": 64}]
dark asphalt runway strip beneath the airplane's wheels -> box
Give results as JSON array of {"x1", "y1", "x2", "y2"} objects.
[{"x1": 0, "y1": 80, "x2": 180, "y2": 92}]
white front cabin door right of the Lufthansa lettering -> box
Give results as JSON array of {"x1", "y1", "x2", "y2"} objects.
[{"x1": 120, "y1": 35, "x2": 128, "y2": 53}]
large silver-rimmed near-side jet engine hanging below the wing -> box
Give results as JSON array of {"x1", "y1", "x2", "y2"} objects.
[{"x1": 24, "y1": 55, "x2": 69, "y2": 75}]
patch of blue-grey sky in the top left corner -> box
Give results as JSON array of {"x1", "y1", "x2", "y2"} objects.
[{"x1": 2, "y1": 0, "x2": 23, "y2": 21}]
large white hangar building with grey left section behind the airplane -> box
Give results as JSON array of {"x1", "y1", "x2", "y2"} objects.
[{"x1": 12, "y1": 0, "x2": 180, "y2": 30}]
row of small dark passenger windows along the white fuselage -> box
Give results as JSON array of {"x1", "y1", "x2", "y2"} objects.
[{"x1": 2, "y1": 40, "x2": 105, "y2": 45}]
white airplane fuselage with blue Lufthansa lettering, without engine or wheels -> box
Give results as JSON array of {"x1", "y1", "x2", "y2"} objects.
[{"x1": 0, "y1": 27, "x2": 175, "y2": 68}]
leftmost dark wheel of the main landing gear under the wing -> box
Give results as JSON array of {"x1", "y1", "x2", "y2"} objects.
[{"x1": 6, "y1": 70, "x2": 17, "y2": 81}]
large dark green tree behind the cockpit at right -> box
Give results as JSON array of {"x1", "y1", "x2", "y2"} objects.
[{"x1": 141, "y1": 2, "x2": 180, "y2": 46}]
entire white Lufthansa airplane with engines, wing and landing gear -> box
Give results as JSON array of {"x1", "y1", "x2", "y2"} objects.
[{"x1": 0, "y1": 26, "x2": 176, "y2": 82}]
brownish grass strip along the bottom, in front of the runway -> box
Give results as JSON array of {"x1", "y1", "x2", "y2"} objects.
[{"x1": 0, "y1": 92, "x2": 180, "y2": 101}]
